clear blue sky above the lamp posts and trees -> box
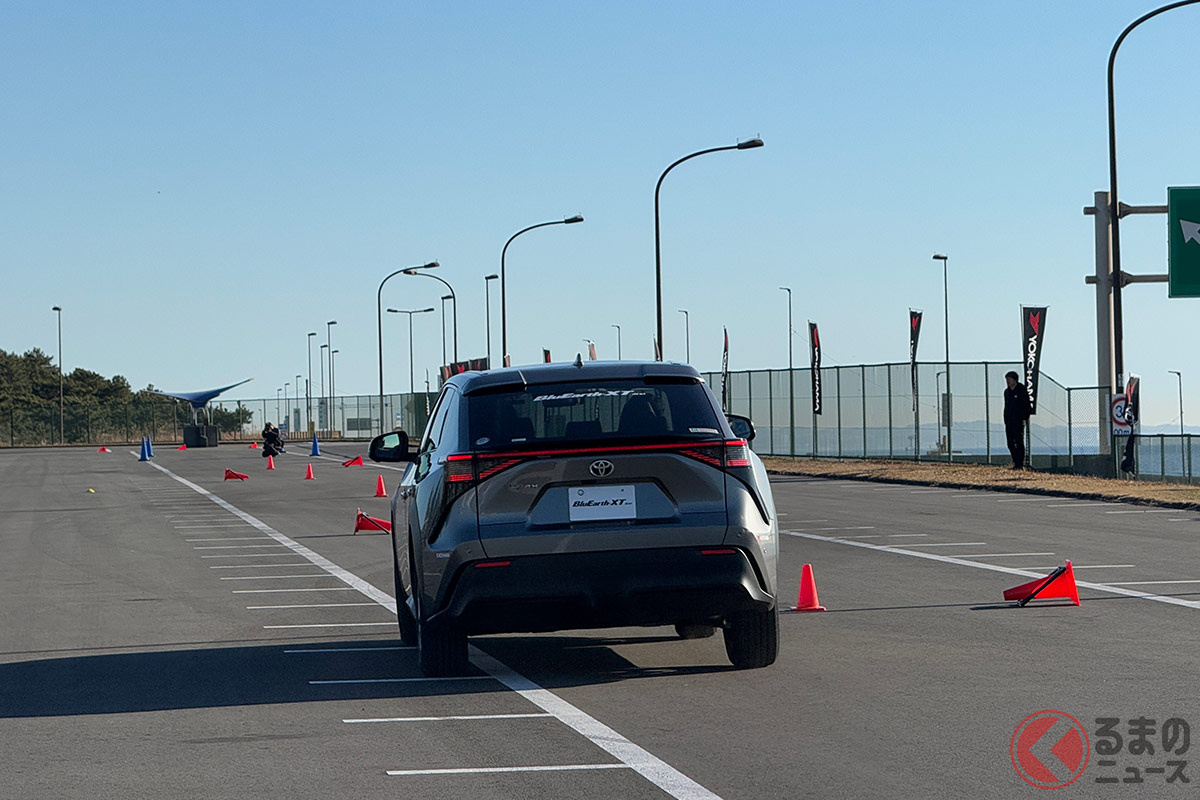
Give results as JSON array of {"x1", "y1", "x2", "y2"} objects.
[{"x1": 0, "y1": 0, "x2": 1200, "y2": 423}]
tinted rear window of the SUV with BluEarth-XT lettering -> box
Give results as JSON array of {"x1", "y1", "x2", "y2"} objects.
[{"x1": 468, "y1": 380, "x2": 722, "y2": 450}]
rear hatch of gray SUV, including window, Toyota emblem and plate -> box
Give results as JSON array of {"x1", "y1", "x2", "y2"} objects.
[{"x1": 456, "y1": 379, "x2": 744, "y2": 558}]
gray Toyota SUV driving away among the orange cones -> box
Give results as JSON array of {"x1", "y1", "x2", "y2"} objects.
[{"x1": 370, "y1": 360, "x2": 779, "y2": 676}]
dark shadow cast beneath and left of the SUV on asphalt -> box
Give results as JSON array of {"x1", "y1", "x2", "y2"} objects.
[{"x1": 0, "y1": 633, "x2": 732, "y2": 718}]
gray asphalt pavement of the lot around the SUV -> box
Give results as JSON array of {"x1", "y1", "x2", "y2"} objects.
[{"x1": 0, "y1": 445, "x2": 1200, "y2": 800}]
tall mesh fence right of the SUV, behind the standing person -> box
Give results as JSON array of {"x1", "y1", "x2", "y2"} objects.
[{"x1": 704, "y1": 362, "x2": 1112, "y2": 475}]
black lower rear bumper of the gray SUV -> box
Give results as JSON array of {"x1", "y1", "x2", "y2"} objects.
[{"x1": 430, "y1": 546, "x2": 775, "y2": 634}]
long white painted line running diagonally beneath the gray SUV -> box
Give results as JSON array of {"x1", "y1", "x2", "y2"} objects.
[{"x1": 140, "y1": 451, "x2": 720, "y2": 800}]
